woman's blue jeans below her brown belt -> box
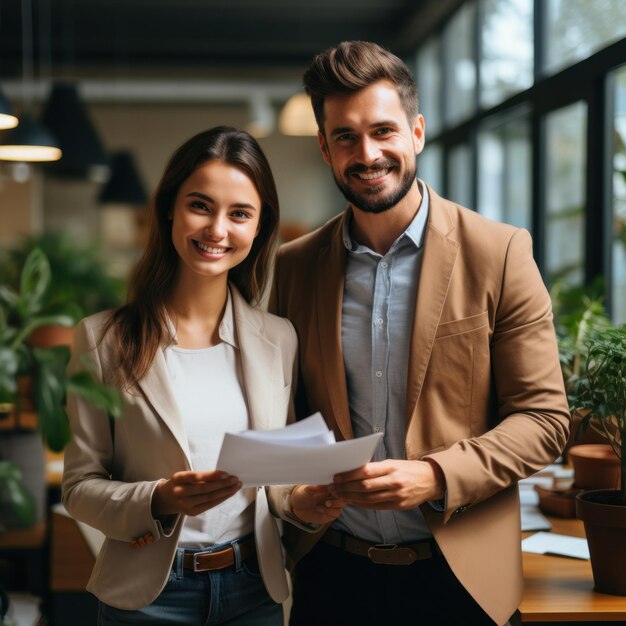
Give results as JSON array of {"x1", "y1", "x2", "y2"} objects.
[{"x1": 98, "y1": 548, "x2": 284, "y2": 626}]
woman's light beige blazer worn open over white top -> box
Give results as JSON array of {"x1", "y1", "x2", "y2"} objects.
[{"x1": 63, "y1": 286, "x2": 296, "y2": 610}]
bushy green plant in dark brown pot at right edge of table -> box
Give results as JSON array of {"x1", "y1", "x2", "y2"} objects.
[{"x1": 568, "y1": 326, "x2": 626, "y2": 595}]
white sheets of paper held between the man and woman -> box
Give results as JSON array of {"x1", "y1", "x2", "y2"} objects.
[{"x1": 217, "y1": 413, "x2": 383, "y2": 487}]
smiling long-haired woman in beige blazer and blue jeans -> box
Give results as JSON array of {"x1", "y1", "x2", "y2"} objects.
[{"x1": 63, "y1": 127, "x2": 296, "y2": 626}]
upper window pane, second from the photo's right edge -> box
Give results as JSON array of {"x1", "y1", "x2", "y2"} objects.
[{"x1": 480, "y1": 0, "x2": 533, "y2": 106}]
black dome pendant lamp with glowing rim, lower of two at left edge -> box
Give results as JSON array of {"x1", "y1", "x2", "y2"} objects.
[{"x1": 0, "y1": 114, "x2": 61, "y2": 162}]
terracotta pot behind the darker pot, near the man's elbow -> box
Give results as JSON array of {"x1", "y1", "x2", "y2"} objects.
[{"x1": 568, "y1": 443, "x2": 620, "y2": 489}]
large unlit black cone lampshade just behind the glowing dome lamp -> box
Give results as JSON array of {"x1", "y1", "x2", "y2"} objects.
[{"x1": 41, "y1": 83, "x2": 109, "y2": 180}]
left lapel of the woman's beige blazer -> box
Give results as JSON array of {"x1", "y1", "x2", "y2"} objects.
[{"x1": 139, "y1": 348, "x2": 191, "y2": 466}]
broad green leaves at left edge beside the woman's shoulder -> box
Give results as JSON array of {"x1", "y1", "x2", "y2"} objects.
[{"x1": 0, "y1": 248, "x2": 122, "y2": 451}]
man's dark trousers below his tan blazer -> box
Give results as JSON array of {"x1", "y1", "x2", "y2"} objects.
[{"x1": 289, "y1": 541, "x2": 494, "y2": 626}]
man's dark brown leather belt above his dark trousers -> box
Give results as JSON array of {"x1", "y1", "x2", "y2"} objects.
[{"x1": 320, "y1": 528, "x2": 441, "y2": 565}]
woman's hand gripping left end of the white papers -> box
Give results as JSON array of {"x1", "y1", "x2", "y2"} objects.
[{"x1": 152, "y1": 470, "x2": 241, "y2": 518}]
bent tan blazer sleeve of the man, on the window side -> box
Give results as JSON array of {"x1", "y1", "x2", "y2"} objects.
[{"x1": 424, "y1": 230, "x2": 570, "y2": 522}]
